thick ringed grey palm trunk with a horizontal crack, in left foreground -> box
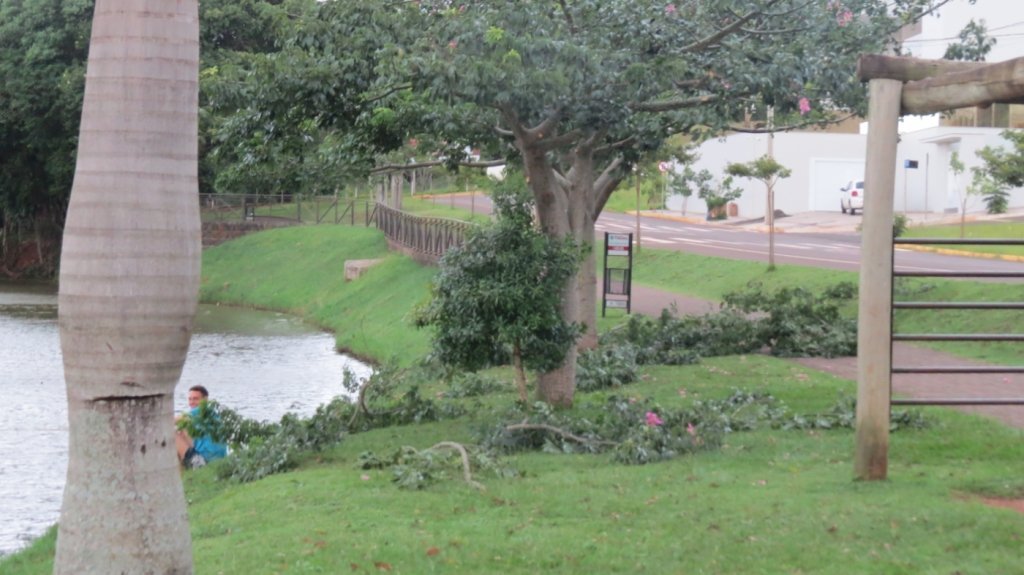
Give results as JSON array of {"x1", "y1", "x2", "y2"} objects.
[{"x1": 54, "y1": 0, "x2": 201, "y2": 574}]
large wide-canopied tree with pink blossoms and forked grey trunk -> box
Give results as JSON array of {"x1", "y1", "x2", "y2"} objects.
[{"x1": 381, "y1": 0, "x2": 944, "y2": 405}]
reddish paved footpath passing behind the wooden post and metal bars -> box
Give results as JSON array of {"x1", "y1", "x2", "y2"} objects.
[{"x1": 622, "y1": 285, "x2": 1024, "y2": 428}]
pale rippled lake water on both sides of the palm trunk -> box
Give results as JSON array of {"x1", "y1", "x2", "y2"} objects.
[{"x1": 0, "y1": 282, "x2": 370, "y2": 555}]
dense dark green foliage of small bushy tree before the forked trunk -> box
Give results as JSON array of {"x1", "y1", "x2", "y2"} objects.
[{"x1": 416, "y1": 176, "x2": 580, "y2": 370}]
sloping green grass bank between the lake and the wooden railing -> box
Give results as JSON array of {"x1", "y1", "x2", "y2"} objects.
[{"x1": 201, "y1": 226, "x2": 435, "y2": 361}]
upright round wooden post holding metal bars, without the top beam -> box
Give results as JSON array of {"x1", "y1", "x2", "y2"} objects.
[{"x1": 854, "y1": 80, "x2": 903, "y2": 480}]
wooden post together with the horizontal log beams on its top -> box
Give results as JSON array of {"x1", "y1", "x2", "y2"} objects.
[{"x1": 854, "y1": 54, "x2": 1024, "y2": 480}]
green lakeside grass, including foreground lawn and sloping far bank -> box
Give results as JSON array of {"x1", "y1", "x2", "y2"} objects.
[{"x1": 0, "y1": 227, "x2": 1024, "y2": 575}]
